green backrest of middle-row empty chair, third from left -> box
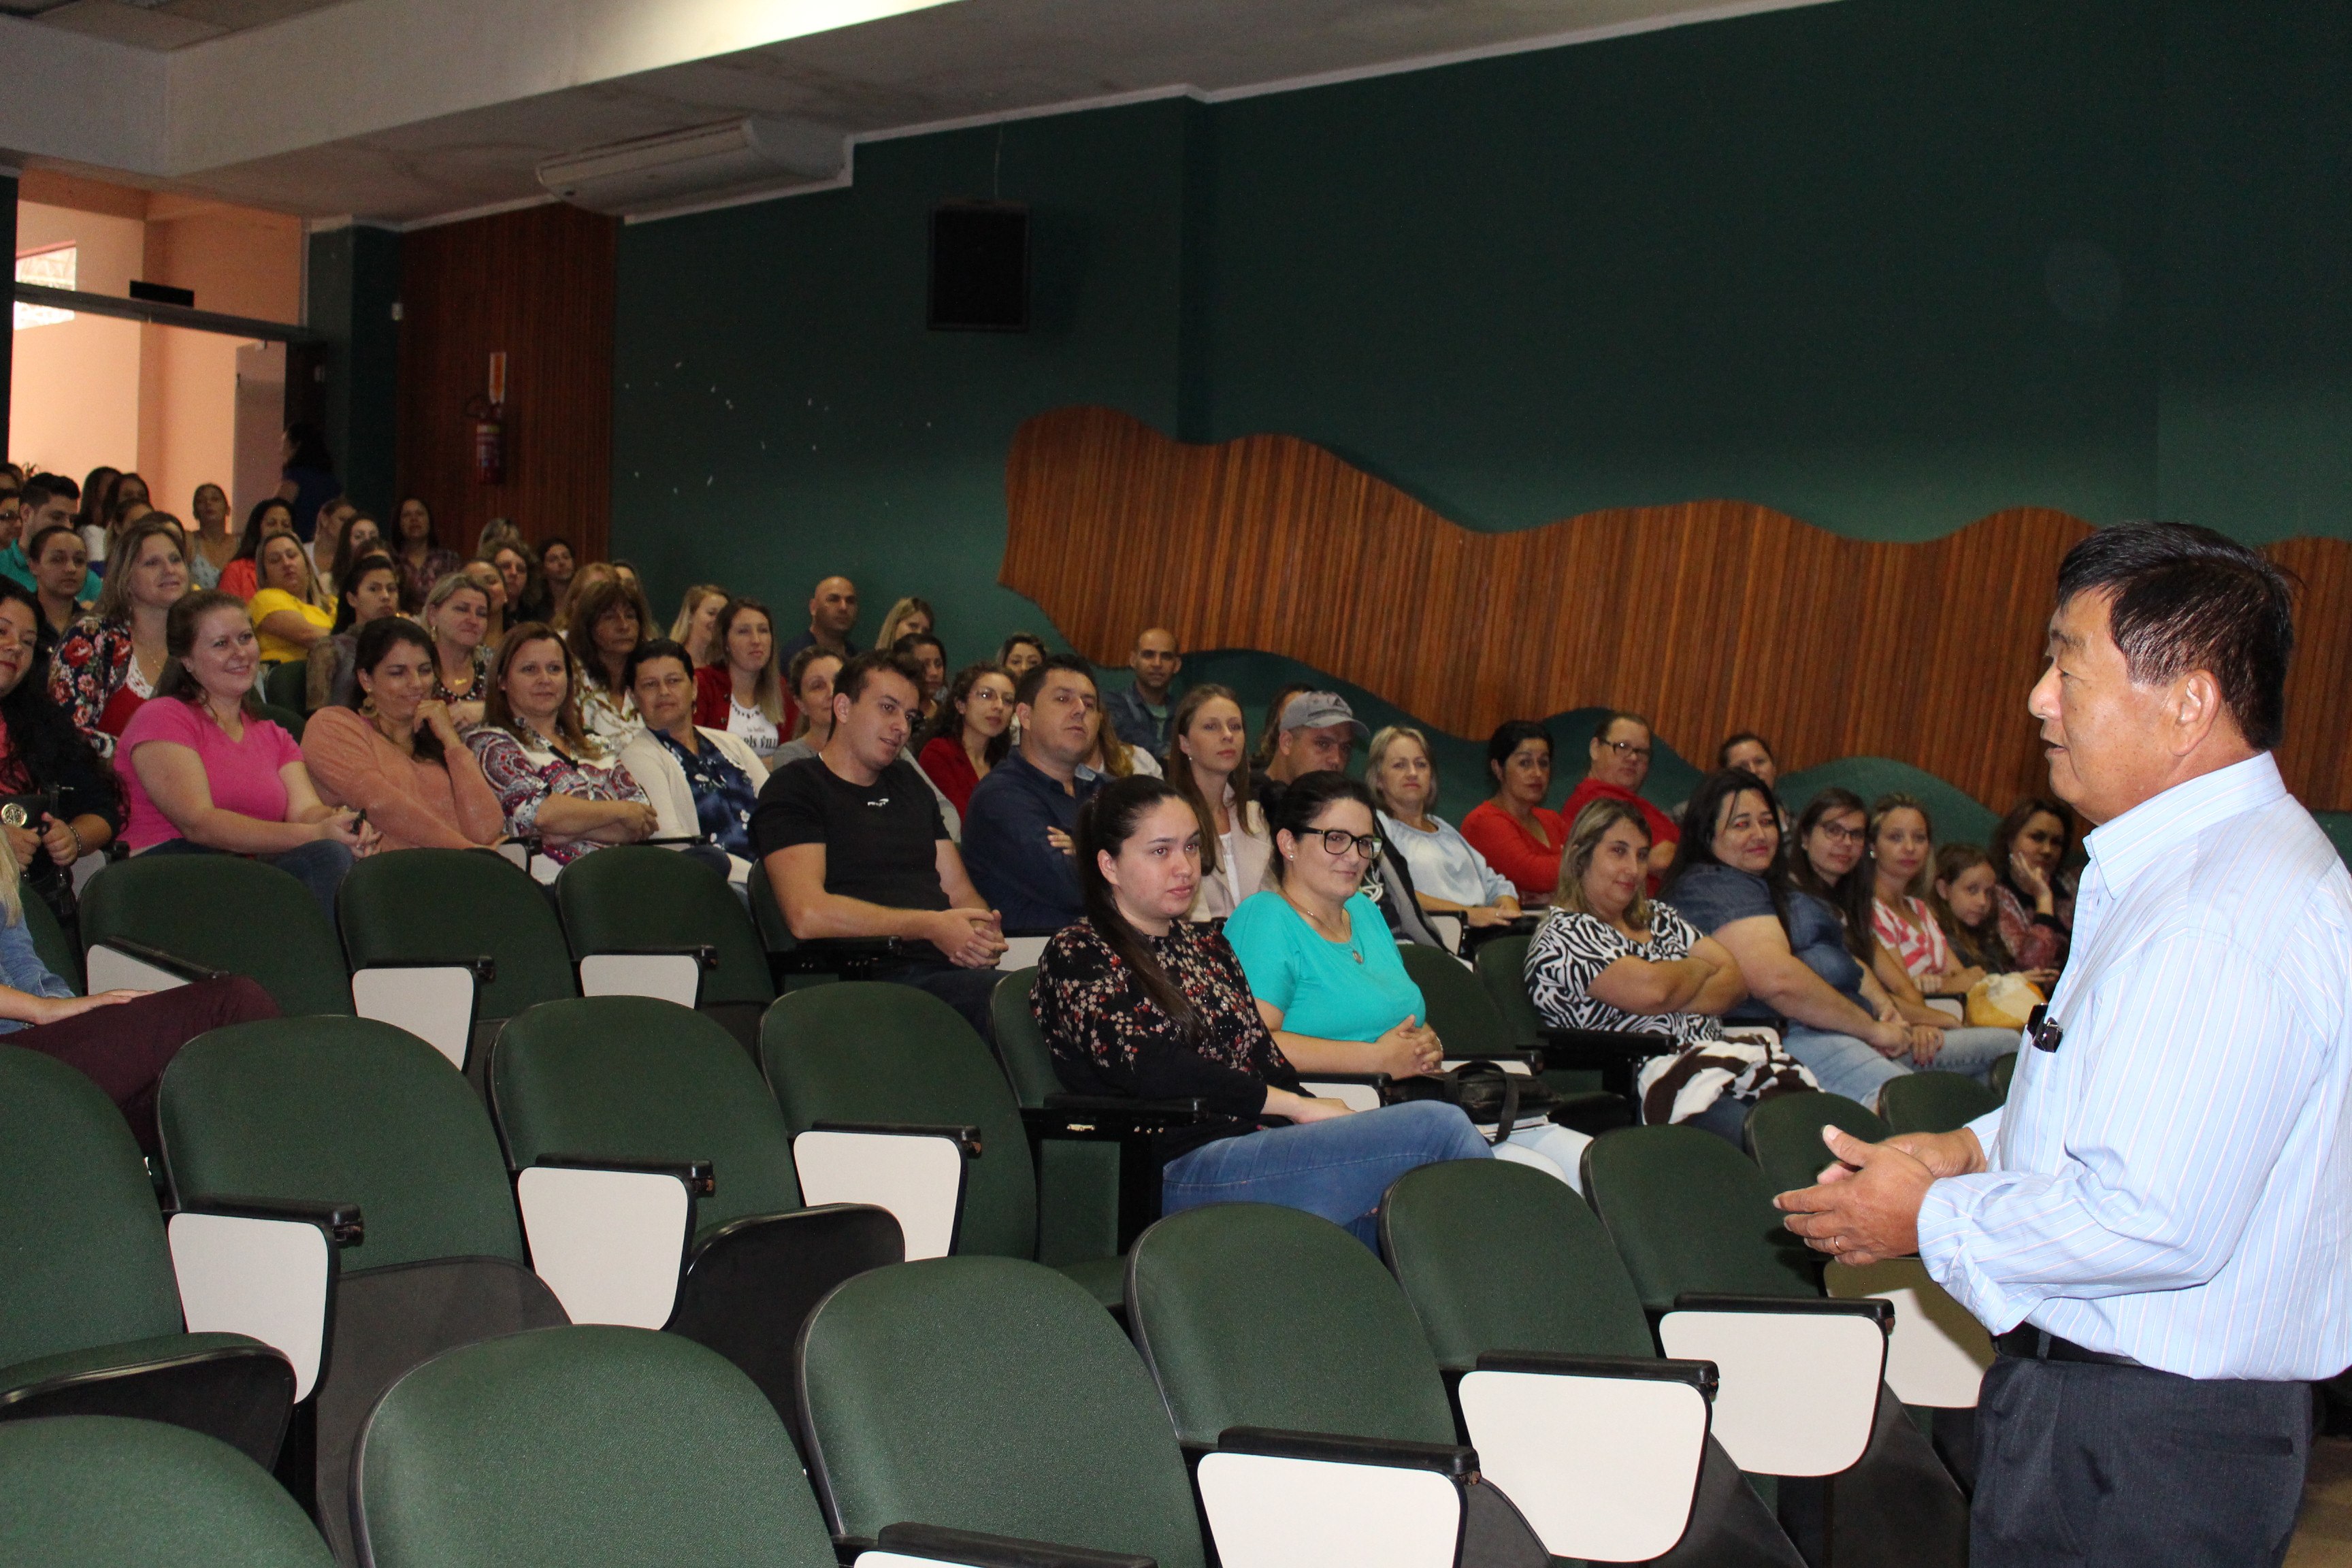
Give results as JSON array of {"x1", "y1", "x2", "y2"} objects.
[{"x1": 489, "y1": 992, "x2": 800, "y2": 1232}]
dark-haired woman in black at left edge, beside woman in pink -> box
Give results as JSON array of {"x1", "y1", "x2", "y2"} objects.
[{"x1": 0, "y1": 587, "x2": 122, "y2": 936}]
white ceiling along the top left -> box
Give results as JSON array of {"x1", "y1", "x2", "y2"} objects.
[{"x1": 0, "y1": 0, "x2": 1820, "y2": 223}]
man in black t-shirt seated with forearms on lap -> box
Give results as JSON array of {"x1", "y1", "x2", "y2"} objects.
[{"x1": 750, "y1": 651, "x2": 1004, "y2": 1041}]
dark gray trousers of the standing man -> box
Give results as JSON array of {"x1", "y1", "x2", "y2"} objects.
[{"x1": 1969, "y1": 1356, "x2": 2312, "y2": 1568}]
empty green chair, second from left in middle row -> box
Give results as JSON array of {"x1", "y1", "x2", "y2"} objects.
[{"x1": 158, "y1": 1018, "x2": 564, "y2": 1561}]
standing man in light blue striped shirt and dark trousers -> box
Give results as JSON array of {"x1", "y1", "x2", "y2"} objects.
[{"x1": 1780, "y1": 524, "x2": 2352, "y2": 1566}]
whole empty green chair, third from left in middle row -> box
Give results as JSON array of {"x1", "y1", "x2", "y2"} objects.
[{"x1": 489, "y1": 1001, "x2": 898, "y2": 1420}]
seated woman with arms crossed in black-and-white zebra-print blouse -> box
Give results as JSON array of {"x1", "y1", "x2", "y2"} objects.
[{"x1": 1526, "y1": 799, "x2": 1820, "y2": 1143}]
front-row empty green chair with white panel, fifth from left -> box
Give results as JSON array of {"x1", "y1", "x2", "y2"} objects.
[{"x1": 1381, "y1": 1159, "x2": 1804, "y2": 1568}]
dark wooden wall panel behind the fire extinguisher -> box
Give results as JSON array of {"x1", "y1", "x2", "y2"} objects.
[{"x1": 383, "y1": 205, "x2": 619, "y2": 559}]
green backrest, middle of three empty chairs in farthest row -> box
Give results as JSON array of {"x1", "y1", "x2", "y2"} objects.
[{"x1": 336, "y1": 849, "x2": 578, "y2": 1020}]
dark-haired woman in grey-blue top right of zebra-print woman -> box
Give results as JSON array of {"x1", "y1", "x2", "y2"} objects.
[{"x1": 1665, "y1": 771, "x2": 1990, "y2": 1107}]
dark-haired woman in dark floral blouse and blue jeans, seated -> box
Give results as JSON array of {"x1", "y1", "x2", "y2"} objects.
[{"x1": 1030, "y1": 776, "x2": 1491, "y2": 1248}]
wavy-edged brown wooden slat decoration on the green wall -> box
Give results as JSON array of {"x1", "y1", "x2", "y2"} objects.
[{"x1": 997, "y1": 407, "x2": 2352, "y2": 808}]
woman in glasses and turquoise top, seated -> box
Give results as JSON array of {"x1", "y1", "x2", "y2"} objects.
[{"x1": 1226, "y1": 771, "x2": 1592, "y2": 1187}]
